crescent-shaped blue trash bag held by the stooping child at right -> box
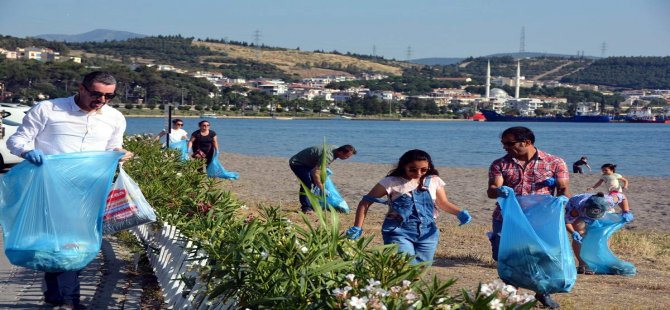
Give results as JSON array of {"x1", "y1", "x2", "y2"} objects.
[{"x1": 579, "y1": 213, "x2": 637, "y2": 276}]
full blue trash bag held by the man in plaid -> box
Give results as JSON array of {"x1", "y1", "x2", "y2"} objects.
[{"x1": 498, "y1": 188, "x2": 577, "y2": 294}]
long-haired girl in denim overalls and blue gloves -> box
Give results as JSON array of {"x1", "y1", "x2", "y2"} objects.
[{"x1": 347, "y1": 150, "x2": 471, "y2": 263}]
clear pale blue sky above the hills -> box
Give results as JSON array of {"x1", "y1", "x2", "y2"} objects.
[{"x1": 0, "y1": 0, "x2": 670, "y2": 60}]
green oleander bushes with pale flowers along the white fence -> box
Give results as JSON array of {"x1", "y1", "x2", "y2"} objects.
[{"x1": 125, "y1": 136, "x2": 534, "y2": 309}]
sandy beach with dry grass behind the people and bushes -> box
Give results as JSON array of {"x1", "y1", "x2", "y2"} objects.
[{"x1": 221, "y1": 153, "x2": 670, "y2": 309}]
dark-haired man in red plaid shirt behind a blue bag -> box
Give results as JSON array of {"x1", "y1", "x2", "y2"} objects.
[{"x1": 486, "y1": 126, "x2": 570, "y2": 309}]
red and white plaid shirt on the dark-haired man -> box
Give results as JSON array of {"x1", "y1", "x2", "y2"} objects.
[{"x1": 489, "y1": 149, "x2": 570, "y2": 221}]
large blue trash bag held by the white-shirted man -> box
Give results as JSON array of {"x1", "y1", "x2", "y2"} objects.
[{"x1": 0, "y1": 152, "x2": 124, "y2": 272}]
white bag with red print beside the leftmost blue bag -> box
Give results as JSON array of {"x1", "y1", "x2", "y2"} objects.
[{"x1": 102, "y1": 166, "x2": 156, "y2": 234}]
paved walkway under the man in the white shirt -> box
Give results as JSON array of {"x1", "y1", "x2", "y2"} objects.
[{"x1": 0, "y1": 230, "x2": 142, "y2": 309}]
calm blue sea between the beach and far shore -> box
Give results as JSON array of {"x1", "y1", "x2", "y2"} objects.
[{"x1": 126, "y1": 118, "x2": 670, "y2": 178}]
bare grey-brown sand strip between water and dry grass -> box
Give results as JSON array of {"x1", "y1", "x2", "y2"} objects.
[{"x1": 221, "y1": 153, "x2": 670, "y2": 232}]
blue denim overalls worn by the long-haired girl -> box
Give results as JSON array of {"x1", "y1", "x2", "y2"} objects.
[{"x1": 382, "y1": 176, "x2": 440, "y2": 263}]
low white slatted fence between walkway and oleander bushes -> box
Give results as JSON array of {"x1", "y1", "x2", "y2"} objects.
[{"x1": 130, "y1": 222, "x2": 234, "y2": 310}]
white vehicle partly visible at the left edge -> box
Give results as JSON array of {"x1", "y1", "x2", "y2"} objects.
[{"x1": 0, "y1": 103, "x2": 30, "y2": 170}]
